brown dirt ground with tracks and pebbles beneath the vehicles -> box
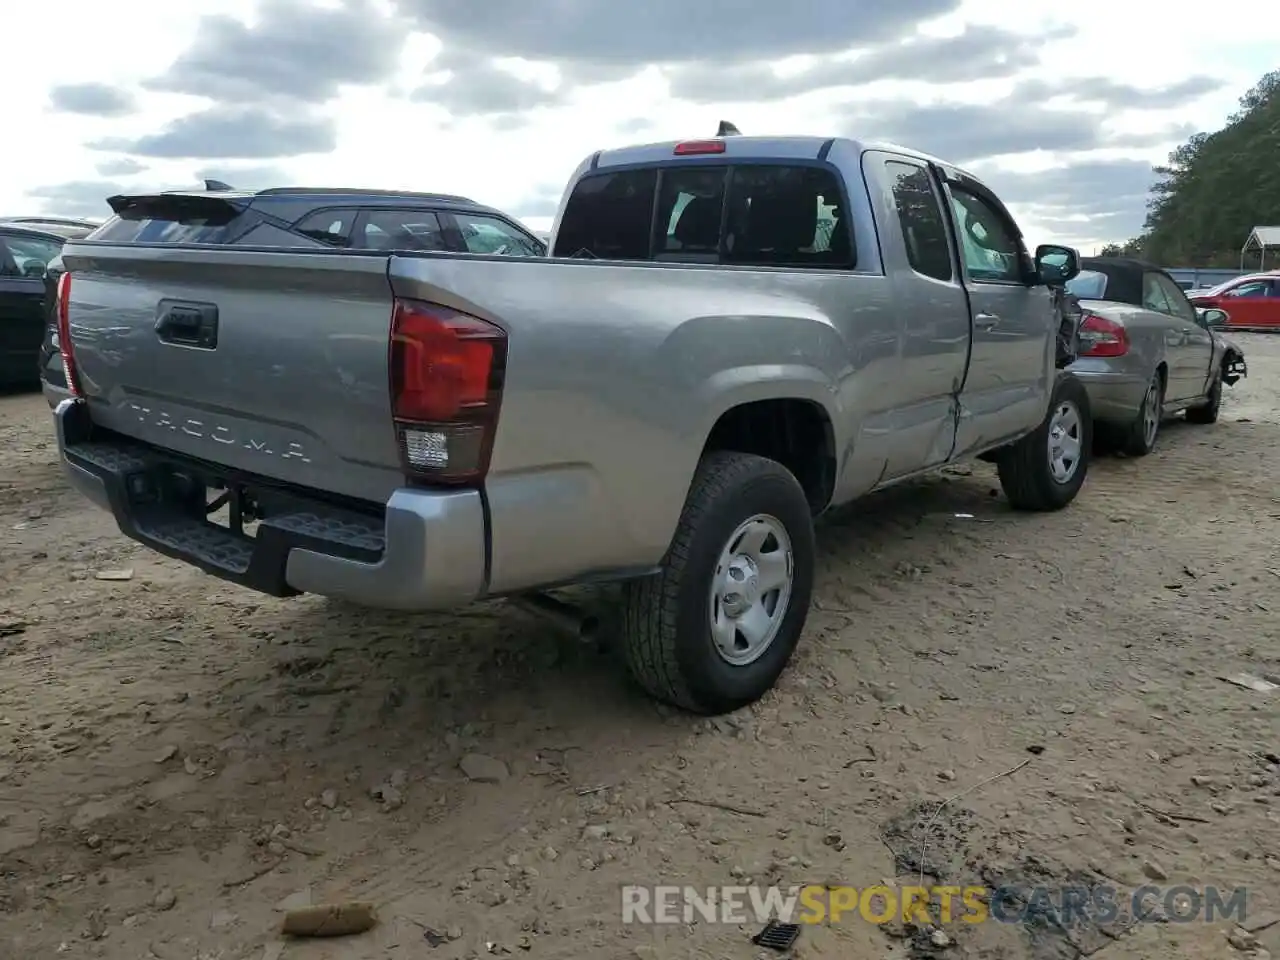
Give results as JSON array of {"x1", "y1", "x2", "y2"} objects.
[{"x1": 0, "y1": 345, "x2": 1280, "y2": 960}]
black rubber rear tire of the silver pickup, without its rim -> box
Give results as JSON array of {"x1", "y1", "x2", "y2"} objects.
[{"x1": 622, "y1": 453, "x2": 815, "y2": 714}]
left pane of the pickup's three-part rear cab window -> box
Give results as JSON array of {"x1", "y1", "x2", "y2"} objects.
[{"x1": 553, "y1": 169, "x2": 658, "y2": 260}]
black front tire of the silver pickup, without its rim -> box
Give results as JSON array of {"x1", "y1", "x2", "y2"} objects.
[{"x1": 996, "y1": 374, "x2": 1093, "y2": 511}]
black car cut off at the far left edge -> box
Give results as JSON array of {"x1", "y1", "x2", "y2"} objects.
[{"x1": 0, "y1": 220, "x2": 81, "y2": 389}]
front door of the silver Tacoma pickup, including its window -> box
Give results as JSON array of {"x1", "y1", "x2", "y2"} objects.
[{"x1": 946, "y1": 185, "x2": 1057, "y2": 457}]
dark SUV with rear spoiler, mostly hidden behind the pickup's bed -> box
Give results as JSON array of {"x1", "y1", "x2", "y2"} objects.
[{"x1": 38, "y1": 182, "x2": 547, "y2": 406}]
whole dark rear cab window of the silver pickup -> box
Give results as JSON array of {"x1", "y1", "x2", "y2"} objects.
[{"x1": 553, "y1": 160, "x2": 855, "y2": 269}]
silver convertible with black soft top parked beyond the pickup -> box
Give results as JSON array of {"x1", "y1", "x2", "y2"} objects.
[{"x1": 1066, "y1": 257, "x2": 1248, "y2": 457}]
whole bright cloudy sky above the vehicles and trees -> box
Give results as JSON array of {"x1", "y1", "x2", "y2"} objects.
[{"x1": 0, "y1": 0, "x2": 1275, "y2": 252}]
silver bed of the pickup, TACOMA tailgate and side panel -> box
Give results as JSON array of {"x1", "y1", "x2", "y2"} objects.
[{"x1": 64, "y1": 243, "x2": 901, "y2": 591}]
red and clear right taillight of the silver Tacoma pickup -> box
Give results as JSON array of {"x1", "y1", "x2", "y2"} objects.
[{"x1": 390, "y1": 300, "x2": 507, "y2": 484}]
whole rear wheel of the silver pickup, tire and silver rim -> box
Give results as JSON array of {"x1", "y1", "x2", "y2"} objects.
[{"x1": 622, "y1": 453, "x2": 815, "y2": 714}]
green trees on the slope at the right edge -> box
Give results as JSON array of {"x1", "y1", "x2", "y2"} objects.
[{"x1": 1102, "y1": 70, "x2": 1280, "y2": 268}]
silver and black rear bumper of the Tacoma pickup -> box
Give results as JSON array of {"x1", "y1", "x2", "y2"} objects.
[{"x1": 54, "y1": 399, "x2": 488, "y2": 611}]
